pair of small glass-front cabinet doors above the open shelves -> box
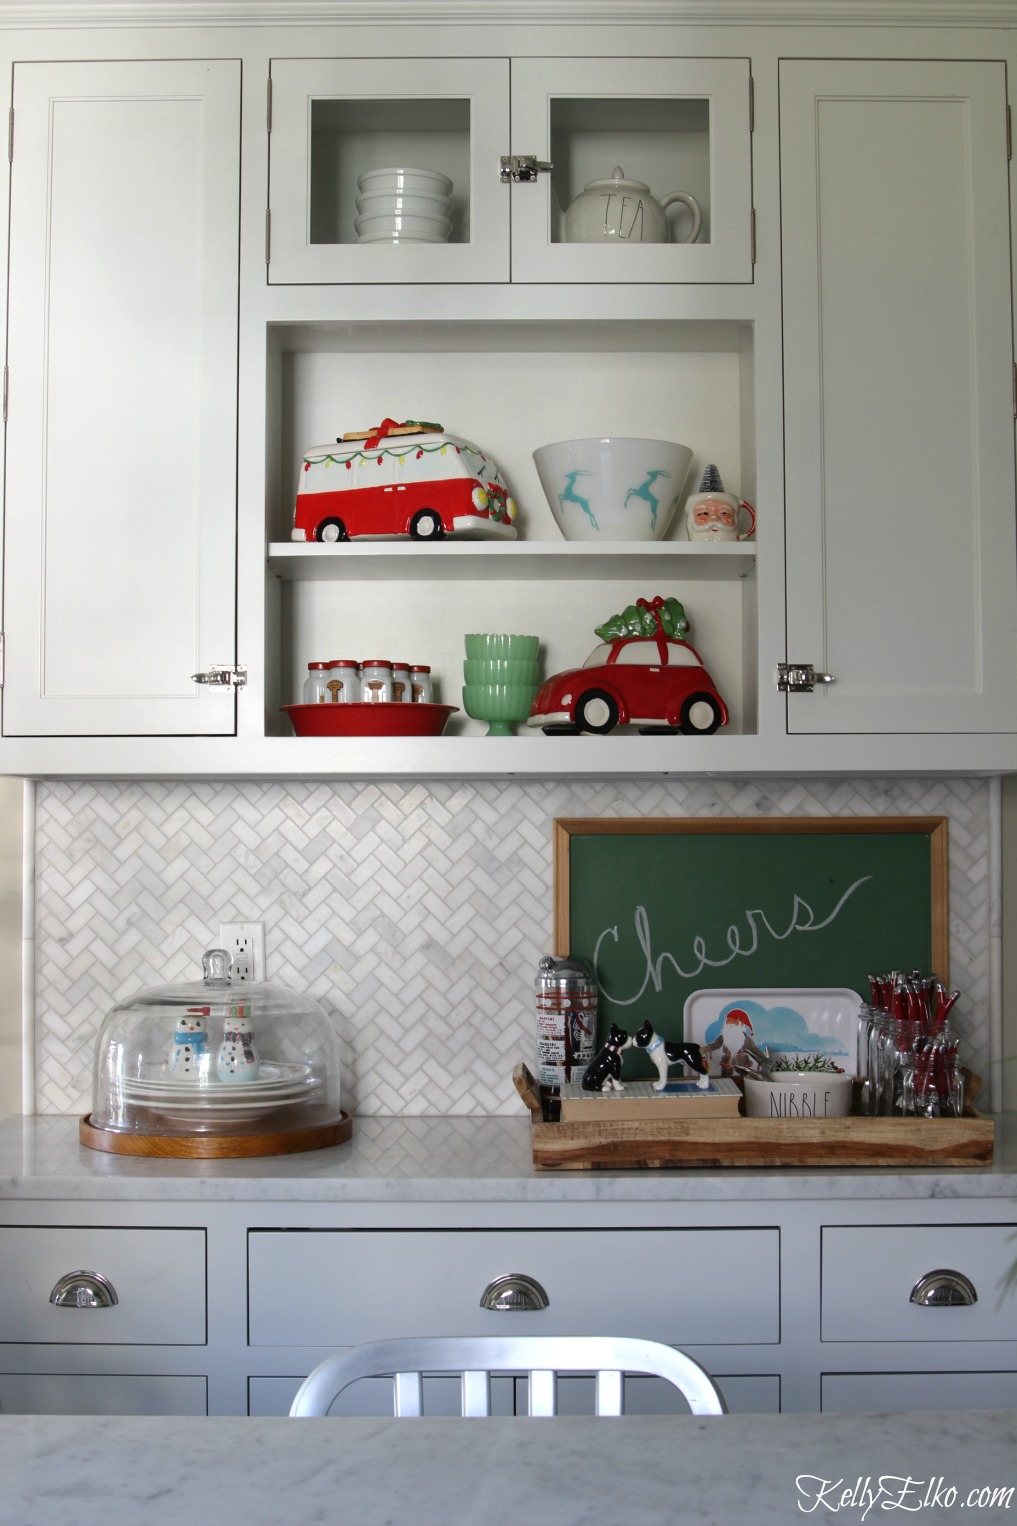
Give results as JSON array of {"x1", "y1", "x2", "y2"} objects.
[{"x1": 269, "y1": 58, "x2": 753, "y2": 285}]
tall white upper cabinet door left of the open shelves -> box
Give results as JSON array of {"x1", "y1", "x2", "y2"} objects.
[{"x1": 3, "y1": 60, "x2": 240, "y2": 737}]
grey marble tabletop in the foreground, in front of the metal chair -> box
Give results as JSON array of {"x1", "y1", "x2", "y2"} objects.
[{"x1": 0, "y1": 1410, "x2": 1017, "y2": 1526}]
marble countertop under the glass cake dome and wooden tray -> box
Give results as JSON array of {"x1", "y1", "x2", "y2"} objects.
[{"x1": 0, "y1": 1114, "x2": 1017, "y2": 1202}]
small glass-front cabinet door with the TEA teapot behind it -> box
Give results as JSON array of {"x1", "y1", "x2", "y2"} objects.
[{"x1": 512, "y1": 58, "x2": 753, "y2": 284}]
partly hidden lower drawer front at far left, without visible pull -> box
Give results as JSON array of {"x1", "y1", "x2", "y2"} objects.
[{"x1": 0, "y1": 1372, "x2": 208, "y2": 1415}]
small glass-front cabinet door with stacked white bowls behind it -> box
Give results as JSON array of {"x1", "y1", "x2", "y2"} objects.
[{"x1": 269, "y1": 58, "x2": 509, "y2": 285}]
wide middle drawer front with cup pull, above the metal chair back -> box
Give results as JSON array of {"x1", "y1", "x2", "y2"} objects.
[{"x1": 247, "y1": 1228, "x2": 780, "y2": 1347}]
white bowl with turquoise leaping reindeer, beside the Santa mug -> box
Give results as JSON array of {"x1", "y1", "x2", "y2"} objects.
[{"x1": 533, "y1": 436, "x2": 692, "y2": 540}]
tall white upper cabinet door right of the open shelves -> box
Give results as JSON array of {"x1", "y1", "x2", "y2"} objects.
[{"x1": 780, "y1": 61, "x2": 1017, "y2": 738}]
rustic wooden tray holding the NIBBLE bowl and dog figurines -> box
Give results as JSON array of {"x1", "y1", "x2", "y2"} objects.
[{"x1": 512, "y1": 1065, "x2": 996, "y2": 1170}]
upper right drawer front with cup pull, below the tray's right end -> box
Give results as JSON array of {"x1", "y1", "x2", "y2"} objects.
[{"x1": 822, "y1": 1224, "x2": 1017, "y2": 1341}]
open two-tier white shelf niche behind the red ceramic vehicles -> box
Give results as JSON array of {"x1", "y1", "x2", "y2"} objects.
[{"x1": 266, "y1": 319, "x2": 757, "y2": 740}]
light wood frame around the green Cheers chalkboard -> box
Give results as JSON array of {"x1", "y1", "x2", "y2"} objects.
[{"x1": 553, "y1": 816, "x2": 950, "y2": 1025}]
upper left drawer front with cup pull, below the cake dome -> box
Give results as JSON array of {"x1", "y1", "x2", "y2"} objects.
[{"x1": 0, "y1": 1227, "x2": 206, "y2": 1346}]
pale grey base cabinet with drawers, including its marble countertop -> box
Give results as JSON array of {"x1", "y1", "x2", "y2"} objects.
[{"x1": 0, "y1": 1117, "x2": 1017, "y2": 1415}]
